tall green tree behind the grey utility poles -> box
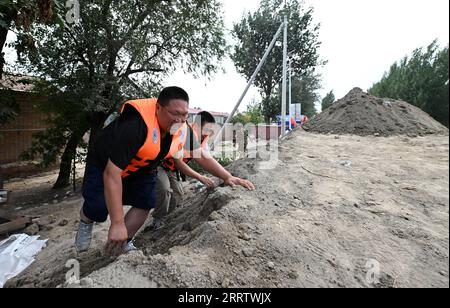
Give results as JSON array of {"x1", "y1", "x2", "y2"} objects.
[{"x1": 232, "y1": 0, "x2": 324, "y2": 121}]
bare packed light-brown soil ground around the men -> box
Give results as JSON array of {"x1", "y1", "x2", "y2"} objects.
[{"x1": 2, "y1": 130, "x2": 449, "y2": 288}]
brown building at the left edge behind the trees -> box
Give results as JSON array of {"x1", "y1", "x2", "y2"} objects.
[{"x1": 0, "y1": 74, "x2": 48, "y2": 177}]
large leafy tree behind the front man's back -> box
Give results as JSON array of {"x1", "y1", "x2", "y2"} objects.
[{"x1": 16, "y1": 0, "x2": 226, "y2": 188}]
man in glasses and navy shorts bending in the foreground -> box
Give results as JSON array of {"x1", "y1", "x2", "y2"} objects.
[{"x1": 75, "y1": 87, "x2": 189, "y2": 255}]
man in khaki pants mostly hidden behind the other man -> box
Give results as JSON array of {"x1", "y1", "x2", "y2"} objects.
[{"x1": 147, "y1": 111, "x2": 255, "y2": 230}]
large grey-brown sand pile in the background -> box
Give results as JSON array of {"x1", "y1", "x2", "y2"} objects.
[{"x1": 304, "y1": 88, "x2": 448, "y2": 136}]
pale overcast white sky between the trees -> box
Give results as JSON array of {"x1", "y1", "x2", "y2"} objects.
[{"x1": 7, "y1": 0, "x2": 449, "y2": 112}]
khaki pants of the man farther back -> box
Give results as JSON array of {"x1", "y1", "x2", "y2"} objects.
[{"x1": 153, "y1": 167, "x2": 183, "y2": 219}]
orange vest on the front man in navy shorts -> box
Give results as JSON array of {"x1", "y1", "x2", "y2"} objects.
[{"x1": 120, "y1": 98, "x2": 187, "y2": 178}]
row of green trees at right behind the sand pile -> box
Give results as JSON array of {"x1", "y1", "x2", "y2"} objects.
[{"x1": 369, "y1": 40, "x2": 449, "y2": 127}]
